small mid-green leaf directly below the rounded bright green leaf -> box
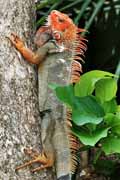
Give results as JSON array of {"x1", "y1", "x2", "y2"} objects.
[{"x1": 102, "y1": 99, "x2": 117, "y2": 113}]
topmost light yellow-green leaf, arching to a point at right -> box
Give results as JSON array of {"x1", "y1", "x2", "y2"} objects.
[{"x1": 75, "y1": 70, "x2": 114, "y2": 97}]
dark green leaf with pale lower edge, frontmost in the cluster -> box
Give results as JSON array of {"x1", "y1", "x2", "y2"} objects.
[{"x1": 72, "y1": 96, "x2": 104, "y2": 126}]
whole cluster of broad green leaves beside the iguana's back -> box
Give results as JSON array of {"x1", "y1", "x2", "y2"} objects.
[{"x1": 51, "y1": 70, "x2": 120, "y2": 155}]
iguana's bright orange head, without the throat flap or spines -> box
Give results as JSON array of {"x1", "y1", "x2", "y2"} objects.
[{"x1": 48, "y1": 10, "x2": 77, "y2": 43}]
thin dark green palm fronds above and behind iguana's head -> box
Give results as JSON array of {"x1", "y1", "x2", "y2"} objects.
[{"x1": 36, "y1": 0, "x2": 120, "y2": 29}]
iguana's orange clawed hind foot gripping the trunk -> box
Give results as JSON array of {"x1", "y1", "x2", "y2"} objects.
[{"x1": 15, "y1": 149, "x2": 54, "y2": 172}]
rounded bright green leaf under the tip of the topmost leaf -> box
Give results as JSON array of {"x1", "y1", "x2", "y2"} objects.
[{"x1": 95, "y1": 78, "x2": 117, "y2": 102}]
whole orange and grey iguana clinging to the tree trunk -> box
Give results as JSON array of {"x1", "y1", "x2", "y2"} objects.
[{"x1": 10, "y1": 10, "x2": 86, "y2": 180}]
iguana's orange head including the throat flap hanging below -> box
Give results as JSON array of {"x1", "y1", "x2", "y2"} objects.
[{"x1": 35, "y1": 10, "x2": 84, "y2": 48}]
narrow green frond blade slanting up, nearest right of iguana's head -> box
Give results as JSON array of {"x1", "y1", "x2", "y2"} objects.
[{"x1": 74, "y1": 0, "x2": 91, "y2": 25}]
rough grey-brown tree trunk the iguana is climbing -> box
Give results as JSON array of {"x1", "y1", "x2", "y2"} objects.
[{"x1": 0, "y1": 0, "x2": 54, "y2": 180}]
